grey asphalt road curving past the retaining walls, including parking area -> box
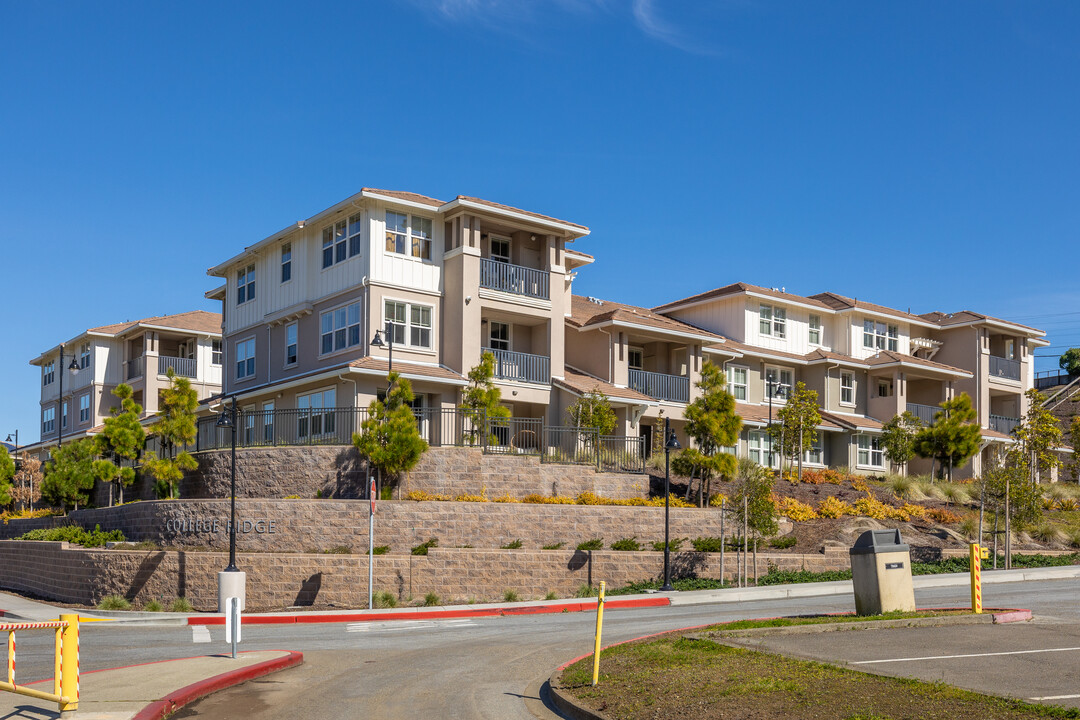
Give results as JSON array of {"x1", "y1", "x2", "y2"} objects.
[{"x1": 8, "y1": 580, "x2": 1080, "y2": 720}]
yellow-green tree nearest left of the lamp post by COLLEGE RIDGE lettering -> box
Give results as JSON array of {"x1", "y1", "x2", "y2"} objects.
[{"x1": 143, "y1": 368, "x2": 199, "y2": 499}]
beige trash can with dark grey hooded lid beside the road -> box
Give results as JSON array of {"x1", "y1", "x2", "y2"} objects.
[{"x1": 850, "y1": 530, "x2": 915, "y2": 615}]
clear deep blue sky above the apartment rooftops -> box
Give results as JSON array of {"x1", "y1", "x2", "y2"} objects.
[{"x1": 0, "y1": 0, "x2": 1080, "y2": 440}]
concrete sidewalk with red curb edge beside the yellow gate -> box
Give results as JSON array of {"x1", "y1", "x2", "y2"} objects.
[{"x1": 0, "y1": 650, "x2": 303, "y2": 720}]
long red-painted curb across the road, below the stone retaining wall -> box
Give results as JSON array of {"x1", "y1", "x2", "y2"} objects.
[{"x1": 188, "y1": 596, "x2": 671, "y2": 625}]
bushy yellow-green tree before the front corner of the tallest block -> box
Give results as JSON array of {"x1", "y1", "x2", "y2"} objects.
[{"x1": 352, "y1": 372, "x2": 428, "y2": 492}]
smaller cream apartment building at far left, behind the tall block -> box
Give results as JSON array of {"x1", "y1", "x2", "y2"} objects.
[{"x1": 30, "y1": 310, "x2": 221, "y2": 449}]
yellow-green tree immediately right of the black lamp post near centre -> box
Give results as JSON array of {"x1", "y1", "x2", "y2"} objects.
[{"x1": 682, "y1": 361, "x2": 742, "y2": 504}]
